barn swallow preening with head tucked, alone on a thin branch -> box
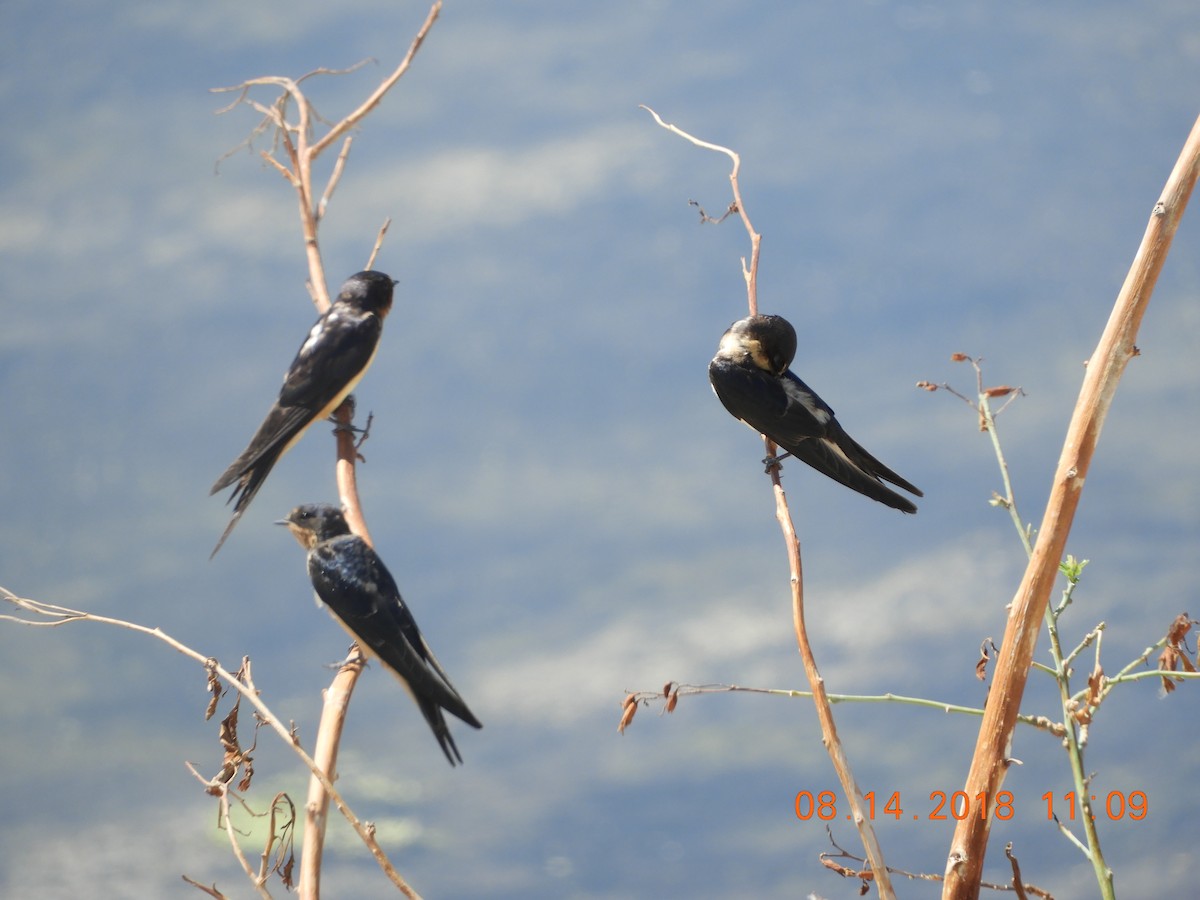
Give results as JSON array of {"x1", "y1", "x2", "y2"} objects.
[{"x1": 708, "y1": 316, "x2": 924, "y2": 512}]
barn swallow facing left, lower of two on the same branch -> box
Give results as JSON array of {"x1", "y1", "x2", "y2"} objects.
[{"x1": 277, "y1": 505, "x2": 484, "y2": 766}]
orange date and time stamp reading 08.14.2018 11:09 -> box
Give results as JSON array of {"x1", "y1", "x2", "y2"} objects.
[{"x1": 796, "y1": 791, "x2": 1150, "y2": 822}]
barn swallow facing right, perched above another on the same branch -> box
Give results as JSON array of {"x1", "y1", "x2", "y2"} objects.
[{"x1": 209, "y1": 271, "x2": 396, "y2": 559}]
